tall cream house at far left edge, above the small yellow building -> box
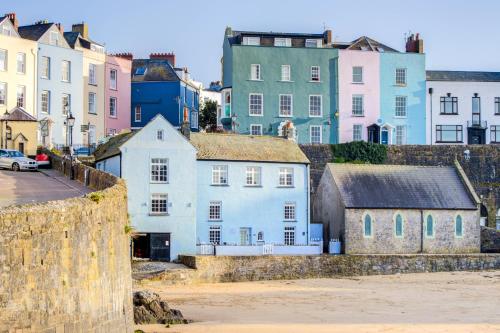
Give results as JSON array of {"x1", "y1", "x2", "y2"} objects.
[{"x1": 0, "y1": 13, "x2": 38, "y2": 116}]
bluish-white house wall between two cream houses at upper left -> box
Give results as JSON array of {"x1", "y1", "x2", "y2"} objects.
[{"x1": 37, "y1": 43, "x2": 83, "y2": 145}]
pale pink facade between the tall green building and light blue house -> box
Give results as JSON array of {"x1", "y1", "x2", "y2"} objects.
[{"x1": 338, "y1": 50, "x2": 380, "y2": 143}]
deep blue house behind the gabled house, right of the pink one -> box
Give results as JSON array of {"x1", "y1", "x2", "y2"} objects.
[{"x1": 131, "y1": 55, "x2": 199, "y2": 131}]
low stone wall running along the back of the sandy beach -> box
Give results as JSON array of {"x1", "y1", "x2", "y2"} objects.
[{"x1": 172, "y1": 254, "x2": 500, "y2": 284}]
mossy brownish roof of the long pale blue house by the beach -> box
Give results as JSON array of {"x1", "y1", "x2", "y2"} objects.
[{"x1": 191, "y1": 133, "x2": 309, "y2": 164}]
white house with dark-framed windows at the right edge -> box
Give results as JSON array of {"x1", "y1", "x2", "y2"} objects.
[{"x1": 427, "y1": 71, "x2": 500, "y2": 144}]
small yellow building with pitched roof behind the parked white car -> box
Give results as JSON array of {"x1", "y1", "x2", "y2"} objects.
[{"x1": 0, "y1": 107, "x2": 38, "y2": 156}]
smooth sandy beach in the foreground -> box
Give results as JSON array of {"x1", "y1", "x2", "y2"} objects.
[{"x1": 137, "y1": 271, "x2": 500, "y2": 333}]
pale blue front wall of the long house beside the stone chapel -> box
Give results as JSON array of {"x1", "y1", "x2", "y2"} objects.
[{"x1": 197, "y1": 160, "x2": 309, "y2": 244}]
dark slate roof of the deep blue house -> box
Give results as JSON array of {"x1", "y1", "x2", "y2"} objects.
[{"x1": 132, "y1": 59, "x2": 180, "y2": 82}]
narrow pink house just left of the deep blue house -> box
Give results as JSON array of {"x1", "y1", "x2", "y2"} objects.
[{"x1": 104, "y1": 54, "x2": 132, "y2": 136}]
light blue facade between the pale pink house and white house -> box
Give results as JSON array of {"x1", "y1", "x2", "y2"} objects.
[{"x1": 380, "y1": 52, "x2": 426, "y2": 144}]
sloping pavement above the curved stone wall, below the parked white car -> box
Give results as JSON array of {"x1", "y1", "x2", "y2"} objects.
[{"x1": 0, "y1": 169, "x2": 92, "y2": 208}]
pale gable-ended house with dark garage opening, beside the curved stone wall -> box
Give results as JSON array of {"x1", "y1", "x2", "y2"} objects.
[{"x1": 95, "y1": 115, "x2": 197, "y2": 261}]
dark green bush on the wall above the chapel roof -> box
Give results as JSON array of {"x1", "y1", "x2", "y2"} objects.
[{"x1": 331, "y1": 141, "x2": 387, "y2": 164}]
